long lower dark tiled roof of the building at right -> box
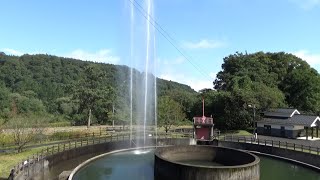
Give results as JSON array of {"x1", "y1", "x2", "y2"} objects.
[{"x1": 258, "y1": 114, "x2": 320, "y2": 127}]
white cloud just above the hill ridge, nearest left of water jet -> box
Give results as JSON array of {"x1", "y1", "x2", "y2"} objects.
[{"x1": 64, "y1": 49, "x2": 120, "y2": 64}]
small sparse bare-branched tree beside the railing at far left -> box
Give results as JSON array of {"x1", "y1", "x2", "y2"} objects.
[{"x1": 6, "y1": 116, "x2": 46, "y2": 152}]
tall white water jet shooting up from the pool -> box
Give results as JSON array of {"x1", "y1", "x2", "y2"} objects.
[{"x1": 130, "y1": 0, "x2": 157, "y2": 146}]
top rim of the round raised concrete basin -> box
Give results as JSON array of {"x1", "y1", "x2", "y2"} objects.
[{"x1": 155, "y1": 145, "x2": 260, "y2": 169}]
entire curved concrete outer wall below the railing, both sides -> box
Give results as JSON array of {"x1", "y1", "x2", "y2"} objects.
[{"x1": 15, "y1": 138, "x2": 320, "y2": 179}]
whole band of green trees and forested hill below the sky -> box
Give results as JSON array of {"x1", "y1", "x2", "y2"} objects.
[{"x1": 0, "y1": 52, "x2": 320, "y2": 134}]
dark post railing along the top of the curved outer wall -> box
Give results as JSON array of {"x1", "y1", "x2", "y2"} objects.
[{"x1": 6, "y1": 132, "x2": 320, "y2": 178}]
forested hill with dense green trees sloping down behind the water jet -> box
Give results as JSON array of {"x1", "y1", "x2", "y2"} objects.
[{"x1": 0, "y1": 53, "x2": 197, "y2": 124}]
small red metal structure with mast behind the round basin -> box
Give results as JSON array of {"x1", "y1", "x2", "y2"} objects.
[{"x1": 193, "y1": 98, "x2": 214, "y2": 142}]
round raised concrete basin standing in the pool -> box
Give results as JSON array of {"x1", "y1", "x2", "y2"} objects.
[{"x1": 154, "y1": 146, "x2": 260, "y2": 180}]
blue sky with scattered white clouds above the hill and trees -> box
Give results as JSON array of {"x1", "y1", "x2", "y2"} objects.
[{"x1": 0, "y1": 0, "x2": 320, "y2": 90}]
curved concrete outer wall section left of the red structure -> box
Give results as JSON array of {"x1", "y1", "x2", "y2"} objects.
[{"x1": 15, "y1": 138, "x2": 190, "y2": 180}]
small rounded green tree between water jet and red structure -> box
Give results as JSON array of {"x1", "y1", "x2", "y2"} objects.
[{"x1": 158, "y1": 96, "x2": 186, "y2": 133}]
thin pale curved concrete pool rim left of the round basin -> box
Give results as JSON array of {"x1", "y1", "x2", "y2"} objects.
[{"x1": 68, "y1": 145, "x2": 171, "y2": 180}]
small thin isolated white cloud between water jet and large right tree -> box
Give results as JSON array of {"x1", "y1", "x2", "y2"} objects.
[{"x1": 182, "y1": 39, "x2": 226, "y2": 49}]
